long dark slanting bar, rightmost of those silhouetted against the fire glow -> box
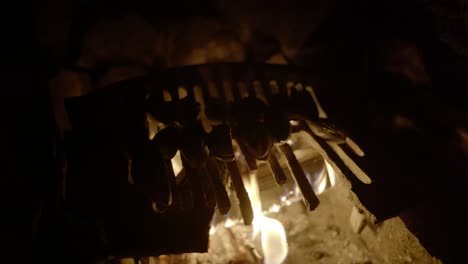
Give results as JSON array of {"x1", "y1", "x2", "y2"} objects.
[{"x1": 279, "y1": 144, "x2": 320, "y2": 211}]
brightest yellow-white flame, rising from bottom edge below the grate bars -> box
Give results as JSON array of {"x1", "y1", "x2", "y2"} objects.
[{"x1": 244, "y1": 174, "x2": 288, "y2": 264}]
